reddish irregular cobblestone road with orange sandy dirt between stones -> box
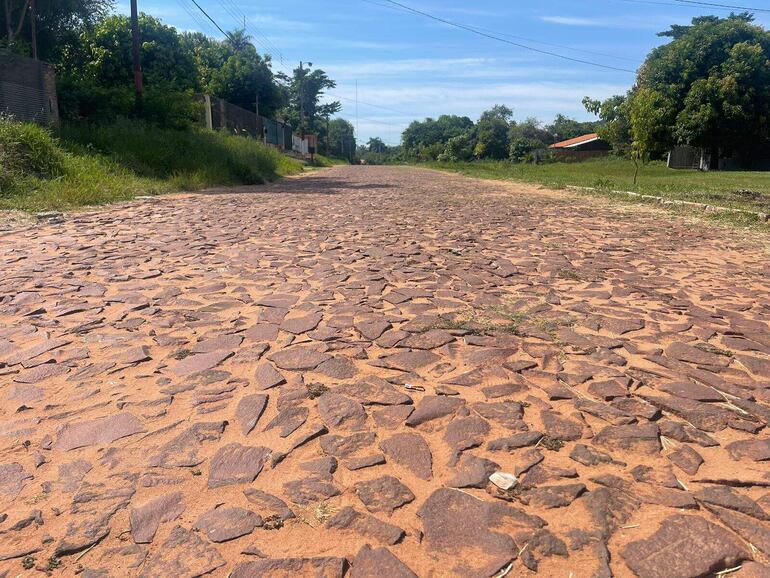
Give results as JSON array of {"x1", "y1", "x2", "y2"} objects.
[{"x1": 0, "y1": 167, "x2": 770, "y2": 578}]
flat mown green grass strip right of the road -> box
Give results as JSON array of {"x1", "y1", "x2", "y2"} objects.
[{"x1": 429, "y1": 157, "x2": 770, "y2": 213}]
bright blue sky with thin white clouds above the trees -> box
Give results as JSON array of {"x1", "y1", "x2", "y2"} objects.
[{"x1": 118, "y1": 0, "x2": 770, "y2": 144}]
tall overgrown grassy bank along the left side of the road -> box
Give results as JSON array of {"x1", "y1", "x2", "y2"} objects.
[{"x1": 0, "y1": 119, "x2": 303, "y2": 211}]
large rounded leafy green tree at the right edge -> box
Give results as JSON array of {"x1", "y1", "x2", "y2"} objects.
[{"x1": 630, "y1": 13, "x2": 770, "y2": 166}]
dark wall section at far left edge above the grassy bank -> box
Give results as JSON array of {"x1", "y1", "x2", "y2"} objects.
[{"x1": 0, "y1": 53, "x2": 59, "y2": 125}]
